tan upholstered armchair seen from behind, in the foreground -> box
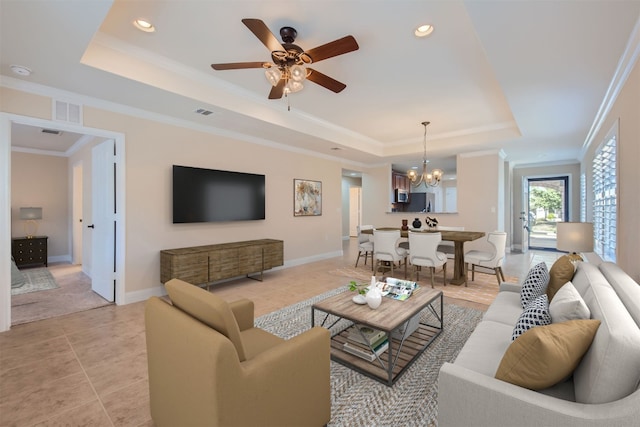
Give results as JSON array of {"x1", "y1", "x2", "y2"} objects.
[{"x1": 145, "y1": 279, "x2": 331, "y2": 427}]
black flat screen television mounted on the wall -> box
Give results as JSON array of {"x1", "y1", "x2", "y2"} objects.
[{"x1": 173, "y1": 165, "x2": 265, "y2": 224}]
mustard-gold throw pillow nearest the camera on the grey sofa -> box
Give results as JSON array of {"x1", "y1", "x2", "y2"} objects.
[{"x1": 495, "y1": 319, "x2": 600, "y2": 390}]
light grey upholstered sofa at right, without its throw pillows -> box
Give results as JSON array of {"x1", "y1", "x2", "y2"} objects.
[{"x1": 438, "y1": 262, "x2": 640, "y2": 427}]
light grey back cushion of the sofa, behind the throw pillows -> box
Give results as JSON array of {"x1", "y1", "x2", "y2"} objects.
[{"x1": 573, "y1": 262, "x2": 640, "y2": 403}]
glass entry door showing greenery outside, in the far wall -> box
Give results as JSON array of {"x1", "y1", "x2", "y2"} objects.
[{"x1": 527, "y1": 176, "x2": 569, "y2": 250}]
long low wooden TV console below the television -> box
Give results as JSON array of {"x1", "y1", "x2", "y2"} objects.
[{"x1": 160, "y1": 239, "x2": 284, "y2": 285}]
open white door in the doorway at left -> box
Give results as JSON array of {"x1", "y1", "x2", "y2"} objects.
[{"x1": 87, "y1": 139, "x2": 117, "y2": 302}]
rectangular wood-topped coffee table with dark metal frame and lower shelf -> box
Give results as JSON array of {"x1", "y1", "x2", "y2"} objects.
[{"x1": 311, "y1": 287, "x2": 444, "y2": 386}]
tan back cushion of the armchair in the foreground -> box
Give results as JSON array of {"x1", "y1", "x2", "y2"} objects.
[{"x1": 165, "y1": 279, "x2": 246, "y2": 362}]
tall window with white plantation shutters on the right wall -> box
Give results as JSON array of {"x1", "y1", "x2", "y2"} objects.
[{"x1": 593, "y1": 135, "x2": 617, "y2": 262}]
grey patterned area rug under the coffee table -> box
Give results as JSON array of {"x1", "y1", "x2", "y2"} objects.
[{"x1": 255, "y1": 287, "x2": 484, "y2": 426}]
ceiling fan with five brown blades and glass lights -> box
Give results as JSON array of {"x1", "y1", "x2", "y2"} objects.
[{"x1": 211, "y1": 19, "x2": 358, "y2": 99}]
